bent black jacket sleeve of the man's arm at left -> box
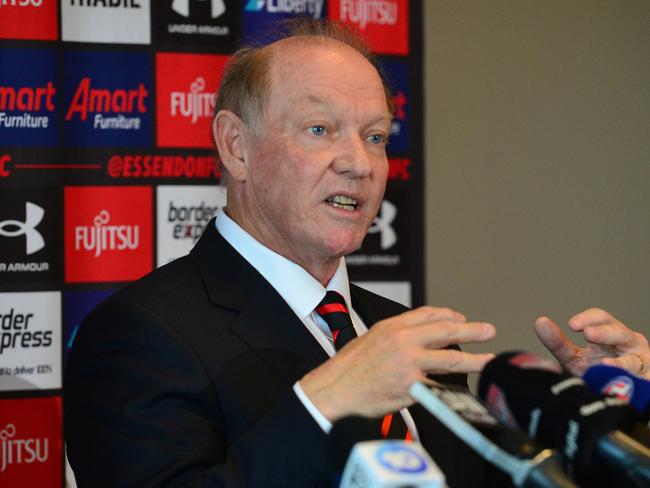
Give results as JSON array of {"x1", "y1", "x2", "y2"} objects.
[{"x1": 64, "y1": 303, "x2": 328, "y2": 488}]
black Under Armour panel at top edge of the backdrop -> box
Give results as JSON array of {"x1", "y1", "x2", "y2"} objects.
[{"x1": 156, "y1": 0, "x2": 241, "y2": 51}]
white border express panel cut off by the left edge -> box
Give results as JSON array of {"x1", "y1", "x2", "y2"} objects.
[{"x1": 0, "y1": 291, "x2": 61, "y2": 390}]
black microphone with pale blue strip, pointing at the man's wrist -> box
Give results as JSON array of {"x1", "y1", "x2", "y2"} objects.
[{"x1": 409, "y1": 381, "x2": 576, "y2": 488}]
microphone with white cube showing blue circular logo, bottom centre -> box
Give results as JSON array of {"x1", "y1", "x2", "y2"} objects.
[{"x1": 330, "y1": 417, "x2": 446, "y2": 488}]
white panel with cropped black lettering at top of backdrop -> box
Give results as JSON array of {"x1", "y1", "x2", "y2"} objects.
[{"x1": 61, "y1": 0, "x2": 151, "y2": 44}]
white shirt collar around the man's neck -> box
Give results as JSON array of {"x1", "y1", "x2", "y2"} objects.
[{"x1": 216, "y1": 208, "x2": 352, "y2": 321}]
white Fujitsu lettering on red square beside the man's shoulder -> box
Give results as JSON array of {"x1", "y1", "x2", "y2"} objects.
[{"x1": 74, "y1": 210, "x2": 140, "y2": 258}]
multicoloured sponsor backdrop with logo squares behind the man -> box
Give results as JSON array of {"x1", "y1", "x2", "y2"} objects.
[{"x1": 0, "y1": 0, "x2": 424, "y2": 488}]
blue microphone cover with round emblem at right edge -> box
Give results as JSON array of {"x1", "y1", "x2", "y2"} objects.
[{"x1": 582, "y1": 364, "x2": 650, "y2": 423}]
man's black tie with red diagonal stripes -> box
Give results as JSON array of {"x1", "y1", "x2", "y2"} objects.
[{"x1": 316, "y1": 291, "x2": 413, "y2": 441}]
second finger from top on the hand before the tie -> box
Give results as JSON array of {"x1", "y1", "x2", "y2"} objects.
[{"x1": 412, "y1": 320, "x2": 496, "y2": 349}]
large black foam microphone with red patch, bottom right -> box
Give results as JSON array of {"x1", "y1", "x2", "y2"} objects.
[{"x1": 479, "y1": 352, "x2": 650, "y2": 487}]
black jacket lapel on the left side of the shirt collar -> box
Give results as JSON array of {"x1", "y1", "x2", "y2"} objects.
[{"x1": 190, "y1": 221, "x2": 328, "y2": 384}]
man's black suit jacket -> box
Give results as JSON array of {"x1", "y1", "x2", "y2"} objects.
[{"x1": 64, "y1": 223, "x2": 483, "y2": 488}]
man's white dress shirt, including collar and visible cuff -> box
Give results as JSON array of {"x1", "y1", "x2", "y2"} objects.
[{"x1": 216, "y1": 208, "x2": 417, "y2": 440}]
